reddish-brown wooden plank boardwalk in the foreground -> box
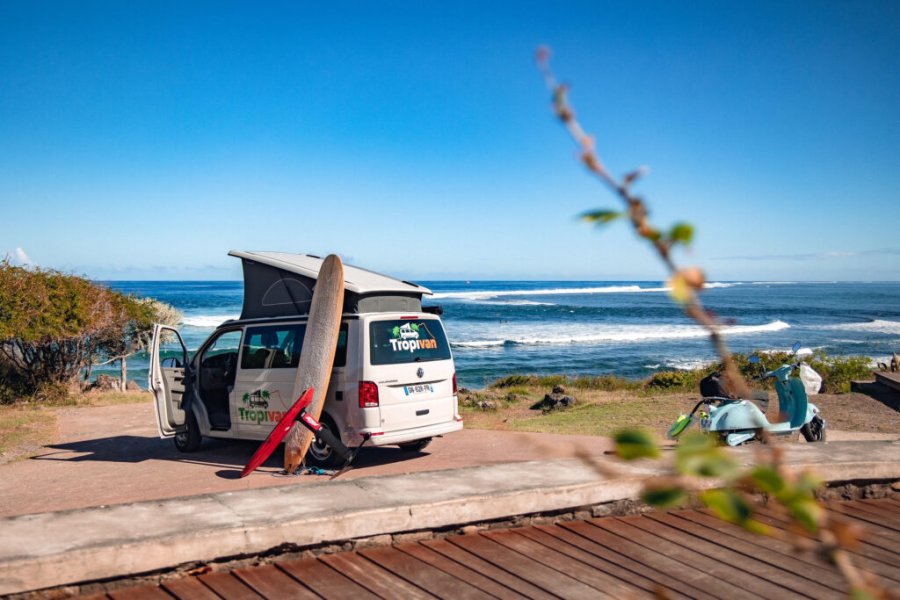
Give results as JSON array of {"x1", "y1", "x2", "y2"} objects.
[{"x1": 81, "y1": 499, "x2": 900, "y2": 600}]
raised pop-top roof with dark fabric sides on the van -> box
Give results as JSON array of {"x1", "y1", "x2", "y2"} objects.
[{"x1": 228, "y1": 250, "x2": 431, "y2": 319}]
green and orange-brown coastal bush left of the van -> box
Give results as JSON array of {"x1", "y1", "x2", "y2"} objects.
[{"x1": 0, "y1": 260, "x2": 180, "y2": 404}]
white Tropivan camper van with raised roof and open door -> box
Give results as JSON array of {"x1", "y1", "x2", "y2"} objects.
[{"x1": 150, "y1": 251, "x2": 463, "y2": 467}]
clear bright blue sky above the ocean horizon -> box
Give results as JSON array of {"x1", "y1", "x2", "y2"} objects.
[{"x1": 0, "y1": 0, "x2": 900, "y2": 281}]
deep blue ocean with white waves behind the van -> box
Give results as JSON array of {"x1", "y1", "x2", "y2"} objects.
[{"x1": 102, "y1": 281, "x2": 900, "y2": 388}]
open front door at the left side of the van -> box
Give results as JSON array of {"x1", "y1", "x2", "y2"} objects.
[{"x1": 149, "y1": 323, "x2": 188, "y2": 437}]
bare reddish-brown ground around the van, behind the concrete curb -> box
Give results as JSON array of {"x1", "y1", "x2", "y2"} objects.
[{"x1": 0, "y1": 390, "x2": 900, "y2": 517}]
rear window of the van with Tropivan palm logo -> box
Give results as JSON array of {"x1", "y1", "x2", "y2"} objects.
[{"x1": 369, "y1": 319, "x2": 450, "y2": 365}]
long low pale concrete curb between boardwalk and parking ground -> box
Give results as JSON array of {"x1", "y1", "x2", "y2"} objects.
[{"x1": 0, "y1": 442, "x2": 900, "y2": 594}]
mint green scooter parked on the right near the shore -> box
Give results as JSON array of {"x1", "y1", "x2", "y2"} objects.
[{"x1": 667, "y1": 342, "x2": 825, "y2": 446}]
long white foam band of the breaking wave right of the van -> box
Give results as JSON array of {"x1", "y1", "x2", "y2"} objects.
[{"x1": 450, "y1": 321, "x2": 790, "y2": 348}]
